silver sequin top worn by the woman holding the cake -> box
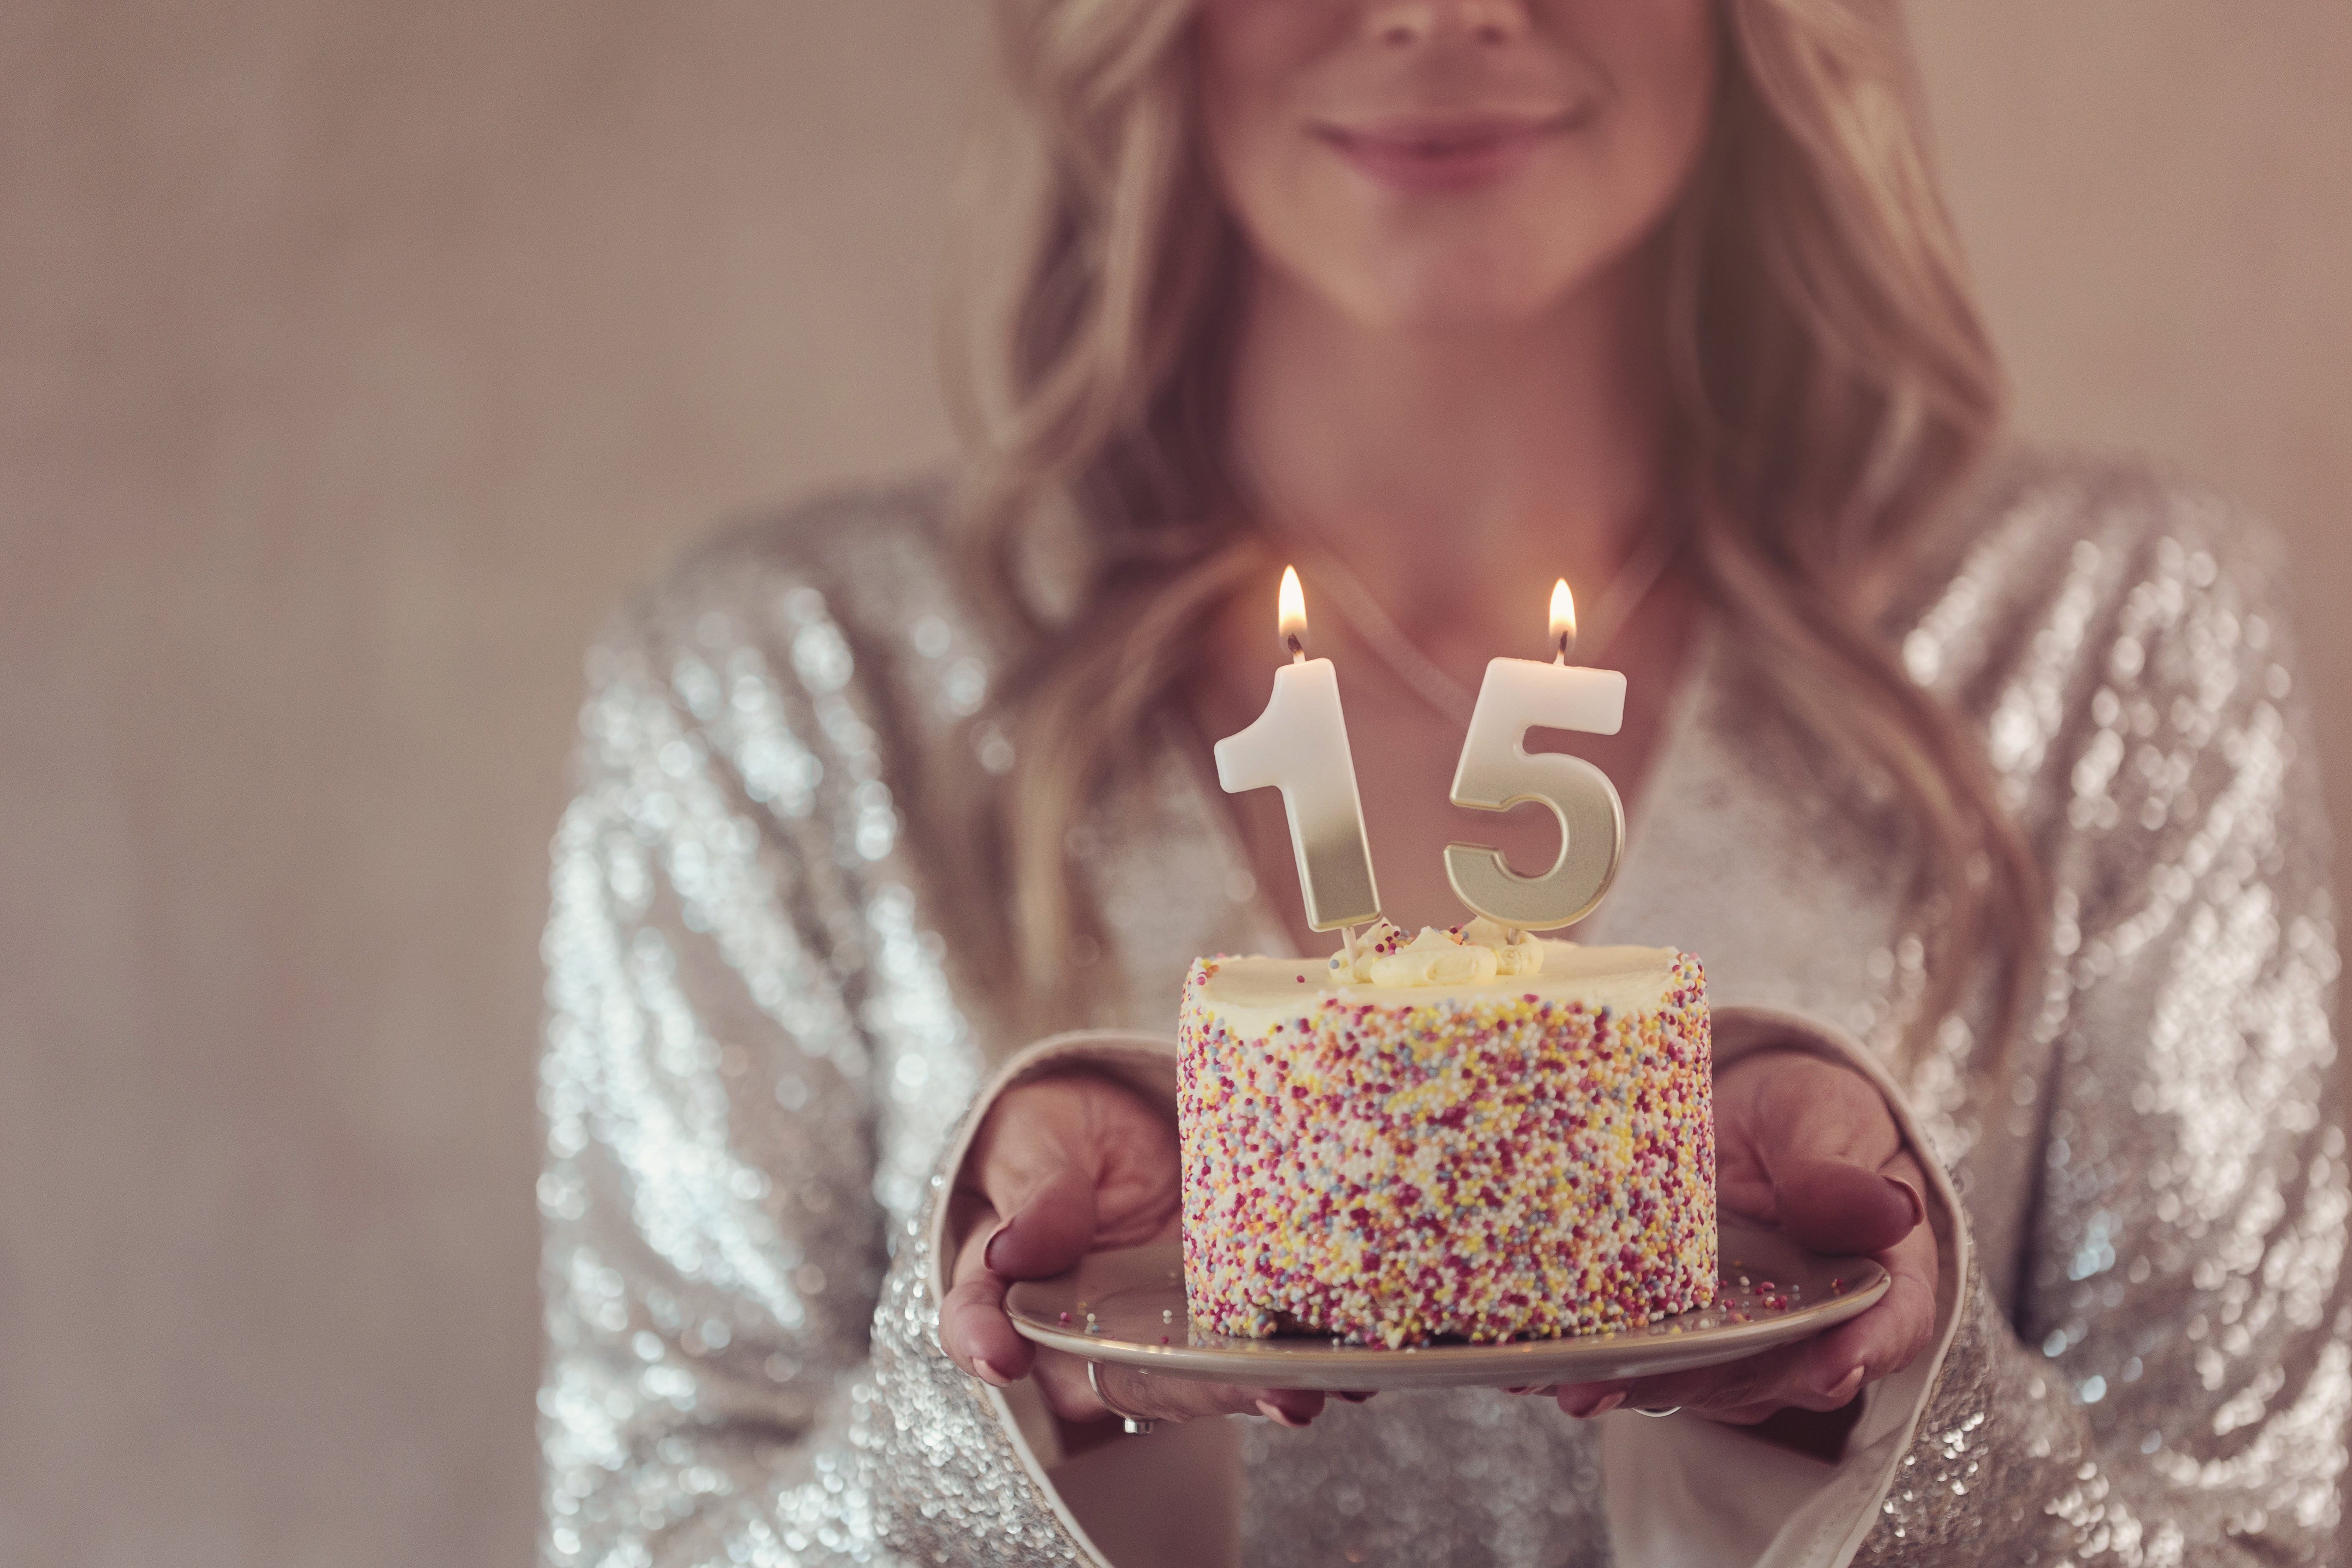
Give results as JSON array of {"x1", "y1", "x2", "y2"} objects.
[{"x1": 539, "y1": 463, "x2": 2352, "y2": 1566}]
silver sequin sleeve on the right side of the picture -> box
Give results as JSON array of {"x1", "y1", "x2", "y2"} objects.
[{"x1": 1858, "y1": 477, "x2": 2352, "y2": 1563}]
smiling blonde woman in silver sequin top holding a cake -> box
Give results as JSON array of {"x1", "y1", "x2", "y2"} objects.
[{"x1": 541, "y1": 0, "x2": 2352, "y2": 1563}]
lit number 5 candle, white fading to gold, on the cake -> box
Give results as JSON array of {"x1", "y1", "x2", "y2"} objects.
[{"x1": 1446, "y1": 581, "x2": 1625, "y2": 931}]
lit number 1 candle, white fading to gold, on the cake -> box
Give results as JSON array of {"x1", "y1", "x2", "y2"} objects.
[{"x1": 1216, "y1": 567, "x2": 1373, "y2": 931}]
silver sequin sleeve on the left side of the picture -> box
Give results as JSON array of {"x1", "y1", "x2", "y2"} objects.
[{"x1": 539, "y1": 503, "x2": 1096, "y2": 1566}]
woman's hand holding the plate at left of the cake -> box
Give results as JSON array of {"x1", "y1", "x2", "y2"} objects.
[{"x1": 938, "y1": 1072, "x2": 1324, "y2": 1427}]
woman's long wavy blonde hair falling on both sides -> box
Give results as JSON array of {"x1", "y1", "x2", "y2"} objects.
[{"x1": 936, "y1": 0, "x2": 2044, "y2": 1067}]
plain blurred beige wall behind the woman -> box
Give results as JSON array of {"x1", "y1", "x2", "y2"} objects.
[{"x1": 0, "y1": 0, "x2": 2352, "y2": 1568}]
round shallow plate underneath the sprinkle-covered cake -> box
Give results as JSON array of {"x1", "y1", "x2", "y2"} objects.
[{"x1": 1004, "y1": 1216, "x2": 1889, "y2": 1389}]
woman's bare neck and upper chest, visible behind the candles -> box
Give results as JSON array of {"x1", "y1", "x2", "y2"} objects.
[{"x1": 1188, "y1": 243, "x2": 1696, "y2": 931}]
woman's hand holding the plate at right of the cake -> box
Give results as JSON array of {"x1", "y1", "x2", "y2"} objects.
[{"x1": 1555, "y1": 1051, "x2": 1936, "y2": 1424}]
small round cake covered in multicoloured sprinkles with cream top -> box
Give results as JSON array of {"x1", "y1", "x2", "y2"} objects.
[{"x1": 1178, "y1": 919, "x2": 1715, "y2": 1347}]
